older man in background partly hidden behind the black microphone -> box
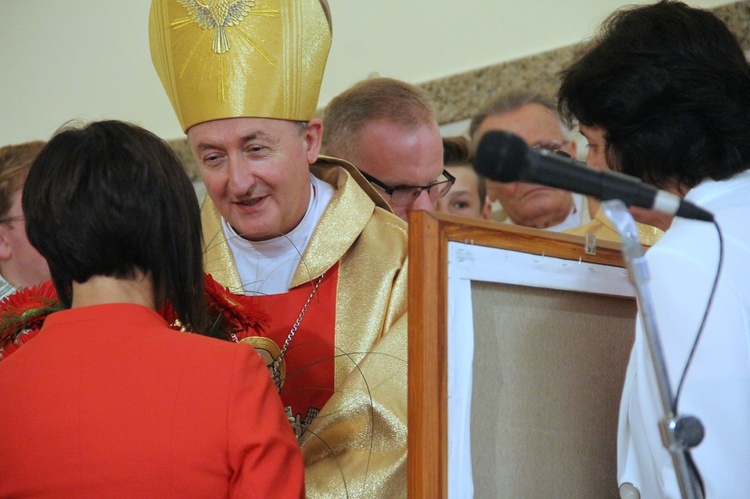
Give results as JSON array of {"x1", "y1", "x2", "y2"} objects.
[{"x1": 469, "y1": 92, "x2": 598, "y2": 231}]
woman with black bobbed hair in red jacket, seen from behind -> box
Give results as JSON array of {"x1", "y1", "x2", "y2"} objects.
[{"x1": 0, "y1": 121, "x2": 304, "y2": 498}]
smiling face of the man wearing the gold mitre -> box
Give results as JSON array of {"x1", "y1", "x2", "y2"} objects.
[{"x1": 188, "y1": 118, "x2": 323, "y2": 241}]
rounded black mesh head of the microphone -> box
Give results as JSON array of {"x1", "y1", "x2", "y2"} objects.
[{"x1": 474, "y1": 130, "x2": 529, "y2": 182}]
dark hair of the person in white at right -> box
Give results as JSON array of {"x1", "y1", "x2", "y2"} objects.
[{"x1": 558, "y1": 1, "x2": 750, "y2": 188}]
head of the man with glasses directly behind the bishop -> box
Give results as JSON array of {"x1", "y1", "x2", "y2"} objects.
[{"x1": 323, "y1": 78, "x2": 455, "y2": 221}]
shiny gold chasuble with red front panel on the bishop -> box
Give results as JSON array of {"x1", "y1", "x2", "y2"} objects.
[{"x1": 202, "y1": 156, "x2": 407, "y2": 498}]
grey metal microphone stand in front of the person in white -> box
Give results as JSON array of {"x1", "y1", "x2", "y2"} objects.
[{"x1": 601, "y1": 199, "x2": 703, "y2": 499}]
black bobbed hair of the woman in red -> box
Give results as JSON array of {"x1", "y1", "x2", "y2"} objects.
[{"x1": 22, "y1": 121, "x2": 204, "y2": 327}]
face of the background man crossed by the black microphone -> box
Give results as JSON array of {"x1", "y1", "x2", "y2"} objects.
[{"x1": 475, "y1": 103, "x2": 576, "y2": 229}]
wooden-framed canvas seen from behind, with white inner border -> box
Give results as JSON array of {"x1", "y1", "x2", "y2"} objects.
[{"x1": 409, "y1": 212, "x2": 636, "y2": 498}]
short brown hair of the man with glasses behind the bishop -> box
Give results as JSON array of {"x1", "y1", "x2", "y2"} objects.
[{"x1": 322, "y1": 78, "x2": 437, "y2": 158}]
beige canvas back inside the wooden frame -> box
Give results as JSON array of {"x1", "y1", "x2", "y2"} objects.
[{"x1": 471, "y1": 281, "x2": 636, "y2": 498}]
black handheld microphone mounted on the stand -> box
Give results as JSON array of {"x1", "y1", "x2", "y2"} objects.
[{"x1": 474, "y1": 130, "x2": 714, "y2": 222}]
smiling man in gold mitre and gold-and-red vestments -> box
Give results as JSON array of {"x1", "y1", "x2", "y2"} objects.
[{"x1": 149, "y1": 0, "x2": 408, "y2": 498}]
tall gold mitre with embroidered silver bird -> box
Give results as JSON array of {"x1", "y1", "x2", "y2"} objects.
[{"x1": 149, "y1": 0, "x2": 331, "y2": 132}]
